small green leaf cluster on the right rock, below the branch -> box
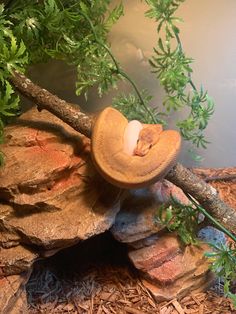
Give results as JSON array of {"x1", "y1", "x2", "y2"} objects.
[{"x1": 155, "y1": 198, "x2": 199, "y2": 244}]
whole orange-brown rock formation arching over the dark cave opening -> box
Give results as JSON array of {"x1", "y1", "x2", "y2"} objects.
[{"x1": 0, "y1": 109, "x2": 214, "y2": 313}]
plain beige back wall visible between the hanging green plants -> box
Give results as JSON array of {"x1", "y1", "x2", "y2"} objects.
[{"x1": 22, "y1": 0, "x2": 236, "y2": 167}]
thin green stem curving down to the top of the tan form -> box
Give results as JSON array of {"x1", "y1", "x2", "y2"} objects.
[{"x1": 81, "y1": 12, "x2": 158, "y2": 124}]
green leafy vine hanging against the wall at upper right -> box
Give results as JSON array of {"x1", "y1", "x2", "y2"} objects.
[{"x1": 146, "y1": 0, "x2": 214, "y2": 148}]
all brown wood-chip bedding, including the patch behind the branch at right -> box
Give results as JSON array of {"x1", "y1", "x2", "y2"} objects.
[{"x1": 27, "y1": 168, "x2": 236, "y2": 314}]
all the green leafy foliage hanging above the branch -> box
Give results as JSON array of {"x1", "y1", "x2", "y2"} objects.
[{"x1": 0, "y1": 0, "x2": 214, "y2": 155}]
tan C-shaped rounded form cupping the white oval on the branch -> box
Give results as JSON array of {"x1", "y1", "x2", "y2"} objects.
[{"x1": 92, "y1": 107, "x2": 181, "y2": 189}]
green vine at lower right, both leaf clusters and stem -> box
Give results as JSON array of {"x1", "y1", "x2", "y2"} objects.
[{"x1": 155, "y1": 196, "x2": 236, "y2": 307}]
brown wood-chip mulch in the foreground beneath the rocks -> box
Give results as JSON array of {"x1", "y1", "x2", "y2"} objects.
[{"x1": 28, "y1": 265, "x2": 236, "y2": 314}]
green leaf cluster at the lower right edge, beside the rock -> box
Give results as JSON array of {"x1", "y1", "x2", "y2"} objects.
[{"x1": 206, "y1": 243, "x2": 236, "y2": 307}]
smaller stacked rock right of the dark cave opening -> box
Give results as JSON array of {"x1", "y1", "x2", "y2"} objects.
[{"x1": 111, "y1": 186, "x2": 214, "y2": 302}]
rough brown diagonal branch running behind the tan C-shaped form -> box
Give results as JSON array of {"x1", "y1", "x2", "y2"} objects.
[{"x1": 11, "y1": 72, "x2": 236, "y2": 233}]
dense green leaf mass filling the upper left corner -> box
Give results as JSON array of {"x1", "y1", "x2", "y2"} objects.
[{"x1": 0, "y1": 0, "x2": 123, "y2": 162}]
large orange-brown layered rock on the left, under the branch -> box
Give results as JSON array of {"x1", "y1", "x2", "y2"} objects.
[{"x1": 0, "y1": 109, "x2": 120, "y2": 308}]
